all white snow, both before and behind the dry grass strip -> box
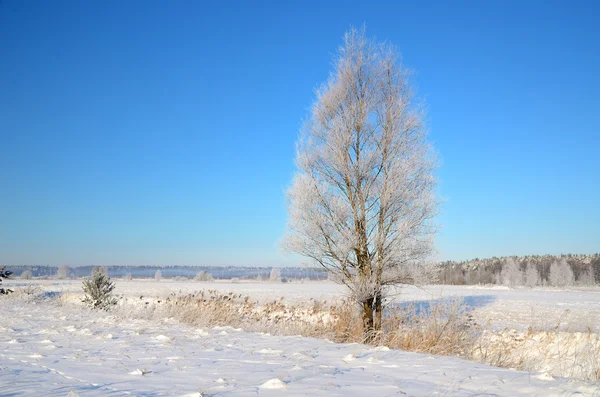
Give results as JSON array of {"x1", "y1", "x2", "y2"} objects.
[{"x1": 0, "y1": 280, "x2": 600, "y2": 396}]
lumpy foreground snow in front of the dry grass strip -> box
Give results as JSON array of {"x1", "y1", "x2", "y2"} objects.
[{"x1": 0, "y1": 299, "x2": 600, "y2": 397}]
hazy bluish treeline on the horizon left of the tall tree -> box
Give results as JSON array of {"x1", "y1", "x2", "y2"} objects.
[{"x1": 7, "y1": 265, "x2": 327, "y2": 280}]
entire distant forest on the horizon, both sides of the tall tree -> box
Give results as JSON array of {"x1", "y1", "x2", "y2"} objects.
[{"x1": 7, "y1": 254, "x2": 600, "y2": 287}]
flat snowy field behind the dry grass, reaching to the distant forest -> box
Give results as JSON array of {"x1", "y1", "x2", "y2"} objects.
[{"x1": 6, "y1": 279, "x2": 600, "y2": 333}]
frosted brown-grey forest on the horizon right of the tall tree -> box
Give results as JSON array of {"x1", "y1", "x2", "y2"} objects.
[{"x1": 439, "y1": 254, "x2": 600, "y2": 287}]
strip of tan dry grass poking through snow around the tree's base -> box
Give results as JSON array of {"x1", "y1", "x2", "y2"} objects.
[{"x1": 150, "y1": 290, "x2": 600, "y2": 380}]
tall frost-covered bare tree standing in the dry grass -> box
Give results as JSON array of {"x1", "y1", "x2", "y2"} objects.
[{"x1": 285, "y1": 29, "x2": 438, "y2": 335}]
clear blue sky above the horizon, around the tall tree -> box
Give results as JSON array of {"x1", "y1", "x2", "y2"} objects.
[{"x1": 0, "y1": 0, "x2": 600, "y2": 265}]
